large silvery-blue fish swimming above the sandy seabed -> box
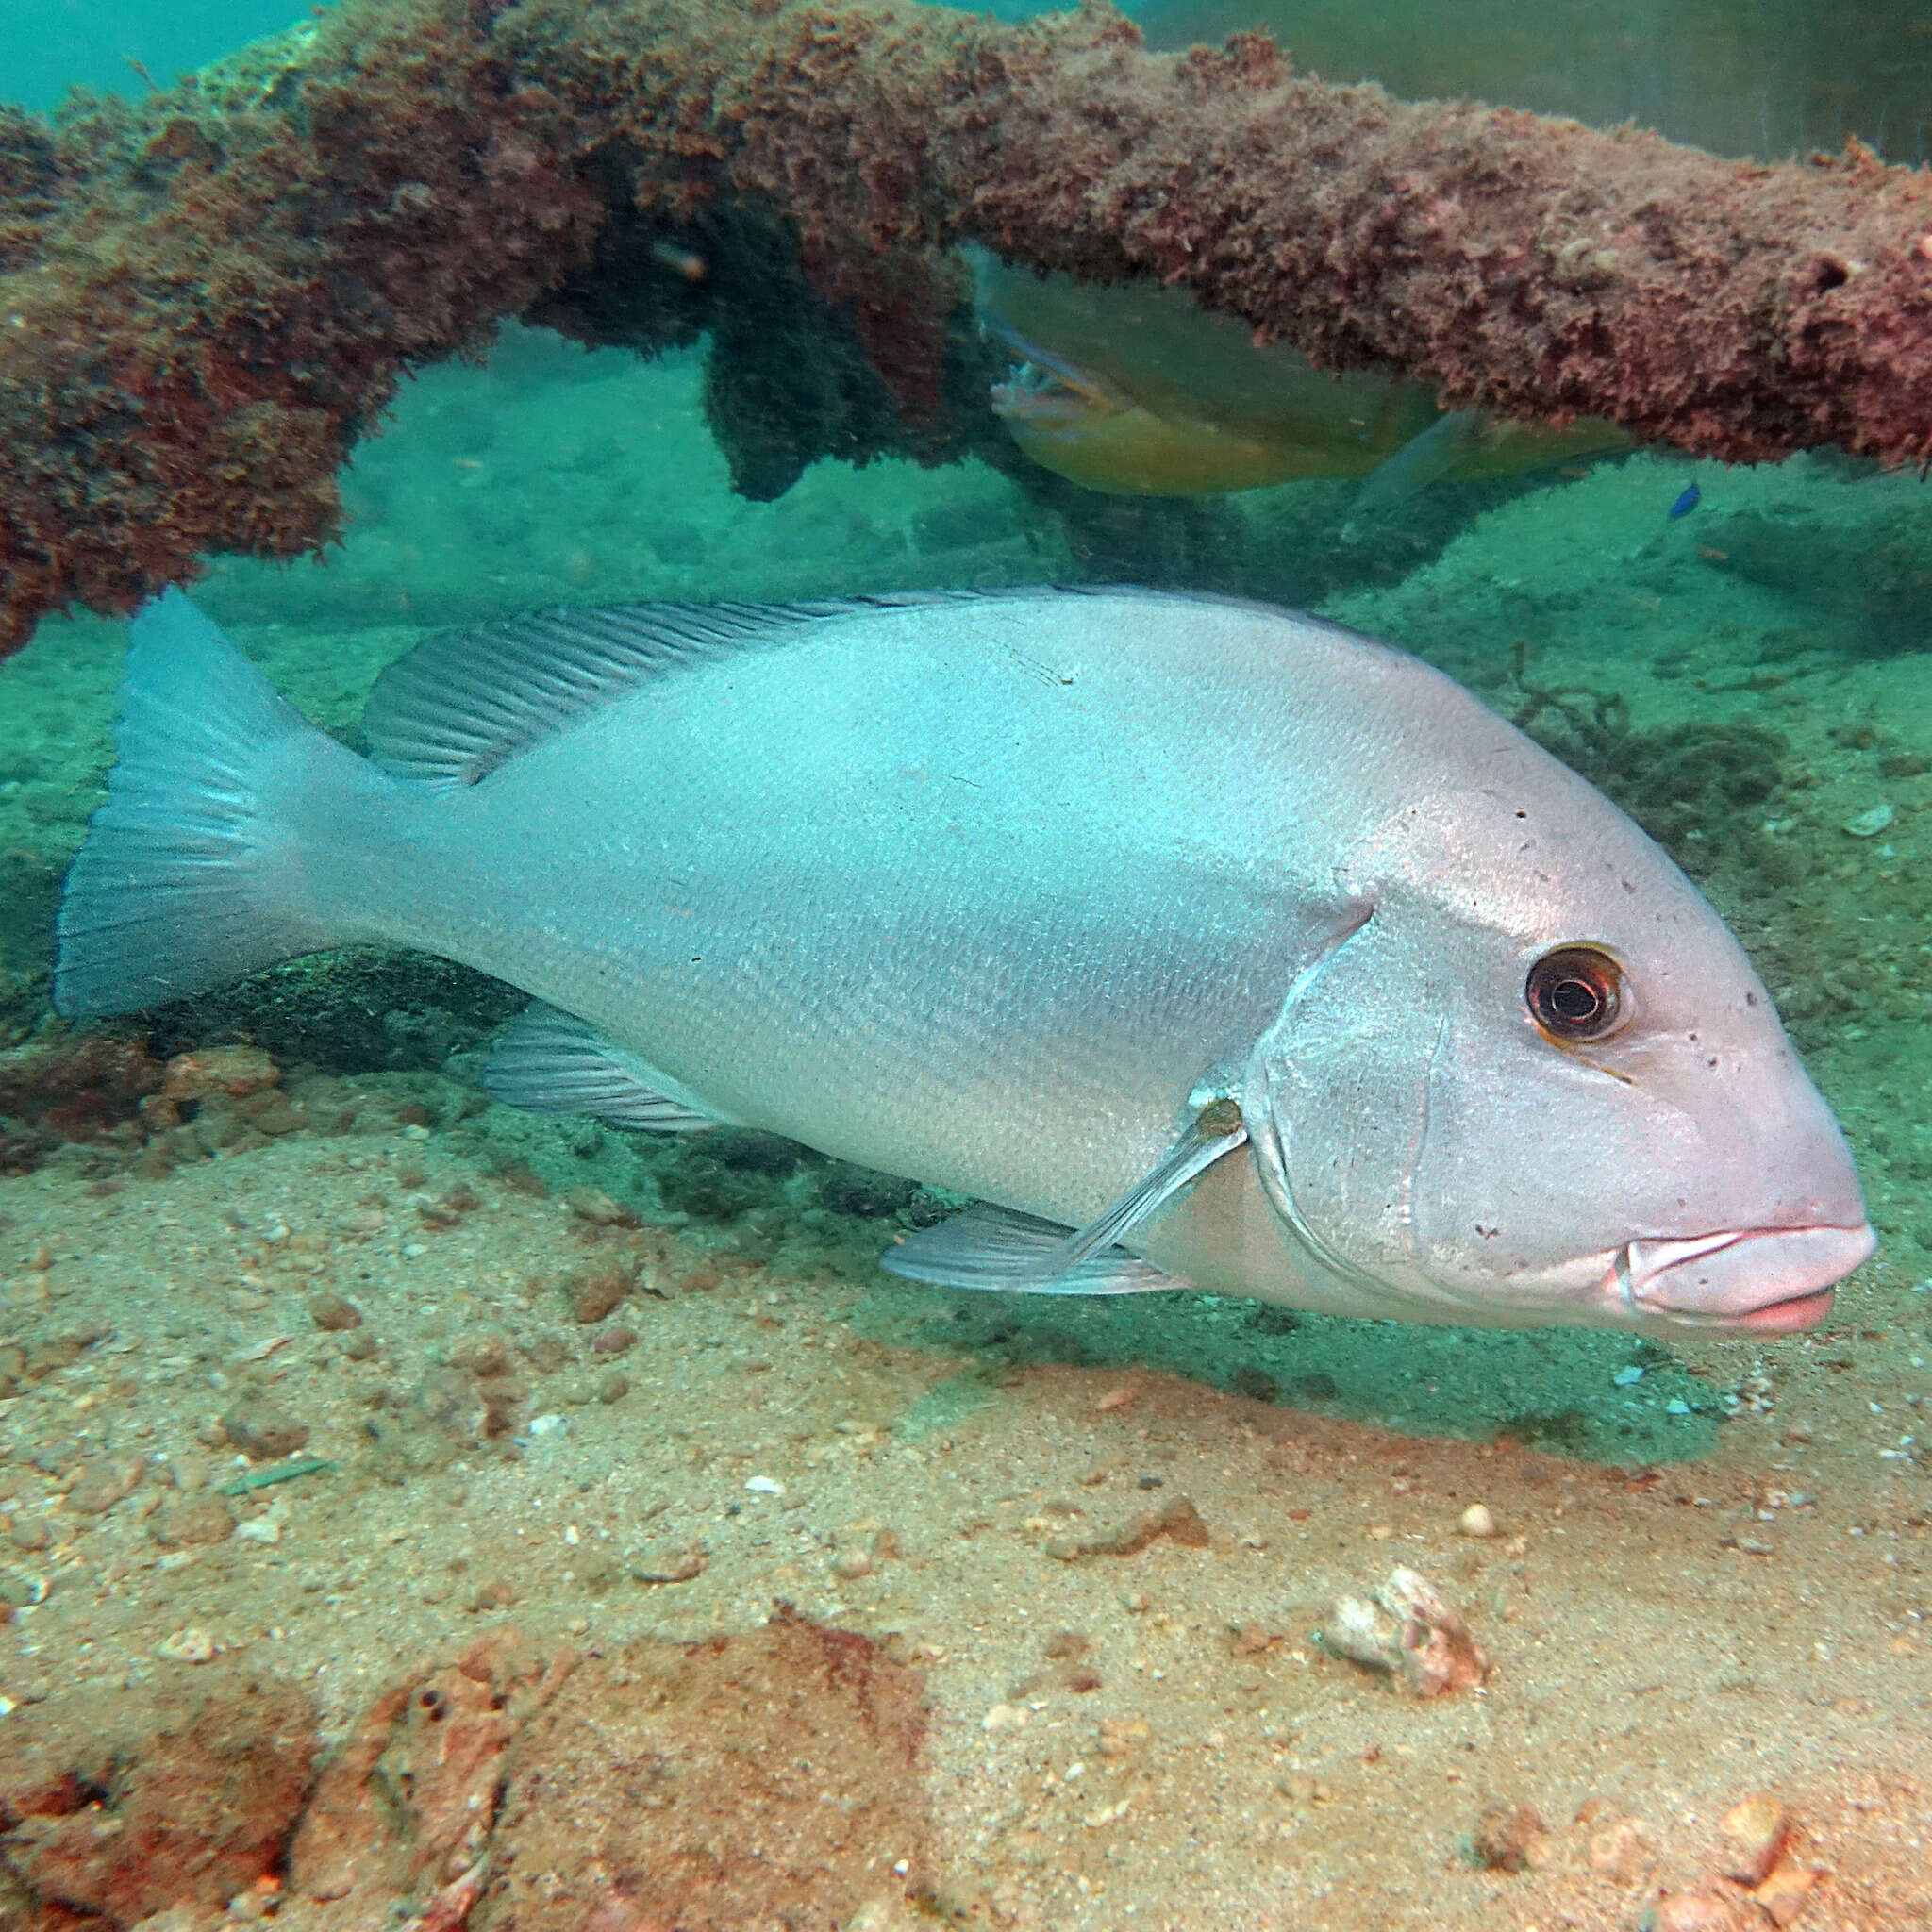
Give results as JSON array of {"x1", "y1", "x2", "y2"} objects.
[{"x1": 54, "y1": 588, "x2": 1874, "y2": 1335}]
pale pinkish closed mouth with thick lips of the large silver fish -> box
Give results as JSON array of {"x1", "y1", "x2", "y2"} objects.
[{"x1": 1600, "y1": 1221, "x2": 1878, "y2": 1335}]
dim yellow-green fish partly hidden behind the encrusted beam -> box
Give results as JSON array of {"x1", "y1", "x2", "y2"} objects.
[{"x1": 968, "y1": 249, "x2": 1633, "y2": 516}]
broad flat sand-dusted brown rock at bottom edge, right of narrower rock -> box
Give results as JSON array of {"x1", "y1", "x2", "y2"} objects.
[{"x1": 472, "y1": 1611, "x2": 933, "y2": 1932}]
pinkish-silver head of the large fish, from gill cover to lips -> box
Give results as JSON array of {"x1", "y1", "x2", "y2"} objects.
[{"x1": 1242, "y1": 774, "x2": 1874, "y2": 1335}]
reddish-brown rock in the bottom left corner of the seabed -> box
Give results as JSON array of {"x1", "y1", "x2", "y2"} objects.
[{"x1": 0, "y1": 1663, "x2": 317, "y2": 1932}]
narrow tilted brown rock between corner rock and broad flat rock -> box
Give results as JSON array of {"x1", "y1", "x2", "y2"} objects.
[{"x1": 286, "y1": 1631, "x2": 575, "y2": 1901}]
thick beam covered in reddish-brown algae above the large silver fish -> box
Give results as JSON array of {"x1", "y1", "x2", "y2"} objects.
[{"x1": 0, "y1": 0, "x2": 1932, "y2": 649}]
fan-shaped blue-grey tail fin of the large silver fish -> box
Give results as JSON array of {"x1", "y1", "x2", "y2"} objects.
[{"x1": 54, "y1": 591, "x2": 365, "y2": 1020}]
